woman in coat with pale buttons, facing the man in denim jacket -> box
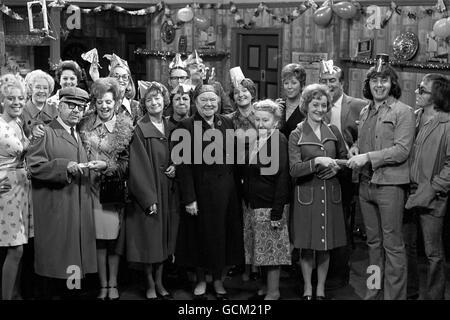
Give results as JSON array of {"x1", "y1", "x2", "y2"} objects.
[{"x1": 289, "y1": 84, "x2": 347, "y2": 300}]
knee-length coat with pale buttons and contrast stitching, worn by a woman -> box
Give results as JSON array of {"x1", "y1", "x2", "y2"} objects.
[{"x1": 289, "y1": 120, "x2": 347, "y2": 250}]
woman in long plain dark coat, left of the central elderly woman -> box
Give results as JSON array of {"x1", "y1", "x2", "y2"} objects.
[{"x1": 125, "y1": 82, "x2": 178, "y2": 299}]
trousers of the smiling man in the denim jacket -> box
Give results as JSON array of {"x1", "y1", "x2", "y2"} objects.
[{"x1": 359, "y1": 181, "x2": 407, "y2": 300}]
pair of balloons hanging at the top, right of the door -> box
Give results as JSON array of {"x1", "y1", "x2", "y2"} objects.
[{"x1": 313, "y1": 1, "x2": 360, "y2": 27}]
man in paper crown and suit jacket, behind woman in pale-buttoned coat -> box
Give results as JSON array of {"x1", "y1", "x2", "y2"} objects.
[{"x1": 319, "y1": 60, "x2": 368, "y2": 249}]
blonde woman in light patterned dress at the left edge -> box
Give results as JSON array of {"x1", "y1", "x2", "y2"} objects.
[{"x1": 0, "y1": 75, "x2": 33, "y2": 300}]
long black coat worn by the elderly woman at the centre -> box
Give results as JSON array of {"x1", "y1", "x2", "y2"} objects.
[{"x1": 176, "y1": 113, "x2": 244, "y2": 270}]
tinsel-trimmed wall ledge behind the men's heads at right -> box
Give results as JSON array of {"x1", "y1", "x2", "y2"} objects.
[{"x1": 341, "y1": 58, "x2": 450, "y2": 73}]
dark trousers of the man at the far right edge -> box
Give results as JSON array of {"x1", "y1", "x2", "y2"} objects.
[{"x1": 404, "y1": 208, "x2": 446, "y2": 300}]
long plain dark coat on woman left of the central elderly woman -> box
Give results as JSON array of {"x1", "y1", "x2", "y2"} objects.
[{"x1": 125, "y1": 114, "x2": 179, "y2": 263}]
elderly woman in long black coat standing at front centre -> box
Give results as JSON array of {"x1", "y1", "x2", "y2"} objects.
[{"x1": 172, "y1": 85, "x2": 244, "y2": 299}]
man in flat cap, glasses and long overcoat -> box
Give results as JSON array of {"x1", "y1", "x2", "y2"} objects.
[{"x1": 27, "y1": 87, "x2": 97, "y2": 293}]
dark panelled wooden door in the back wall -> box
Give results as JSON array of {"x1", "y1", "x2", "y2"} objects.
[{"x1": 236, "y1": 32, "x2": 281, "y2": 99}]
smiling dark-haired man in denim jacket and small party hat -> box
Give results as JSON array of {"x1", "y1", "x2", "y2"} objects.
[{"x1": 348, "y1": 56, "x2": 415, "y2": 300}]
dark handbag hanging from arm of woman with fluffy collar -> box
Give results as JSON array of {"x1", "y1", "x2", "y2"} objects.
[{"x1": 100, "y1": 175, "x2": 128, "y2": 206}]
